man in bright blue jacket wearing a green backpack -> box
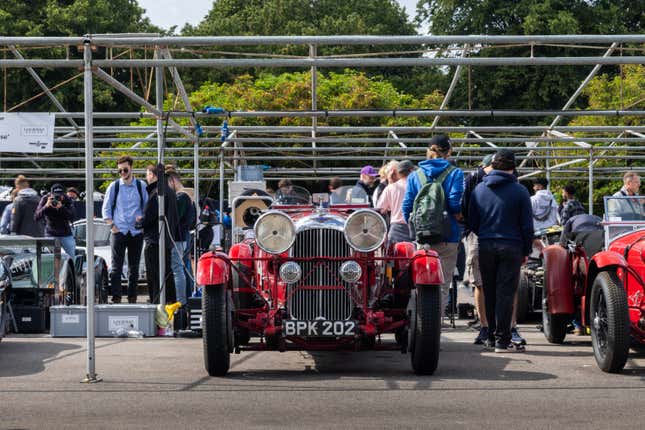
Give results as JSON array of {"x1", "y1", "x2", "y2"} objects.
[{"x1": 401, "y1": 135, "x2": 464, "y2": 320}]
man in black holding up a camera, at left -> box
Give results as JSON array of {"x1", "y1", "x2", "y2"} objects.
[{"x1": 34, "y1": 184, "x2": 76, "y2": 257}]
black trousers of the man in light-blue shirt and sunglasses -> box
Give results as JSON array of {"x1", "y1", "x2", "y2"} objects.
[{"x1": 110, "y1": 233, "x2": 143, "y2": 298}]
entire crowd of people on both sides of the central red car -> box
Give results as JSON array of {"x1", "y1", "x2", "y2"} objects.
[{"x1": 0, "y1": 135, "x2": 640, "y2": 342}]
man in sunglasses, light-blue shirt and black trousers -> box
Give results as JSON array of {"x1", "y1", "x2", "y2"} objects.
[{"x1": 102, "y1": 155, "x2": 148, "y2": 303}]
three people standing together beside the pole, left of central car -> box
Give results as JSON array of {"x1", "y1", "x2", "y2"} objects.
[{"x1": 102, "y1": 155, "x2": 197, "y2": 306}]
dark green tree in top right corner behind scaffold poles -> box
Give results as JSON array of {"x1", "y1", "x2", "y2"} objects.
[{"x1": 416, "y1": 0, "x2": 645, "y2": 124}]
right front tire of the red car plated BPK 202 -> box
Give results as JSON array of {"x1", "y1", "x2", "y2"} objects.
[{"x1": 410, "y1": 285, "x2": 441, "y2": 375}]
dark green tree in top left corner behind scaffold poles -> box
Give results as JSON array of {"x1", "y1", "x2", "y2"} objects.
[{"x1": 0, "y1": 0, "x2": 160, "y2": 111}]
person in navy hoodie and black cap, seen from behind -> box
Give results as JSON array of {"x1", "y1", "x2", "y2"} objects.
[{"x1": 468, "y1": 149, "x2": 533, "y2": 352}]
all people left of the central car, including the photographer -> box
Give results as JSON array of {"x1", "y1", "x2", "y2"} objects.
[{"x1": 0, "y1": 156, "x2": 197, "y2": 305}]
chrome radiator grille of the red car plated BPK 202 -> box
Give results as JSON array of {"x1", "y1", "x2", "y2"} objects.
[{"x1": 287, "y1": 228, "x2": 352, "y2": 320}]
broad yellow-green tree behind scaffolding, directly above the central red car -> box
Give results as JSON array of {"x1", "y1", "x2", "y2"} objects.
[{"x1": 102, "y1": 70, "x2": 443, "y2": 191}]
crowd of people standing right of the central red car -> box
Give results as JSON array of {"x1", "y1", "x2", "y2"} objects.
[{"x1": 358, "y1": 135, "x2": 640, "y2": 352}]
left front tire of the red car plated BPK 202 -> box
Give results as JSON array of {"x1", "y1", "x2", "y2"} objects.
[{"x1": 202, "y1": 285, "x2": 231, "y2": 376}]
